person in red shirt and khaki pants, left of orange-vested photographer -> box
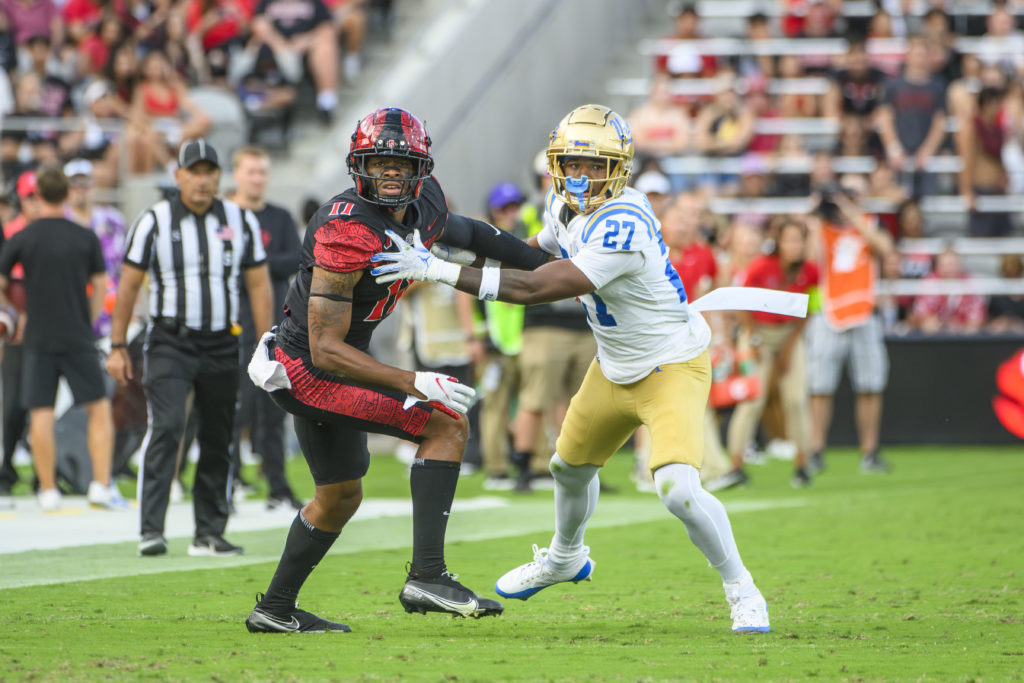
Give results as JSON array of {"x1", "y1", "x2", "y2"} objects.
[{"x1": 728, "y1": 219, "x2": 818, "y2": 488}]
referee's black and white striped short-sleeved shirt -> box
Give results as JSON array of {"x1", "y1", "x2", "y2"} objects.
[{"x1": 124, "y1": 197, "x2": 266, "y2": 332}]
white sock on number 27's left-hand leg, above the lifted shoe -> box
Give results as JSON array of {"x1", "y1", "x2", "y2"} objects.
[{"x1": 548, "y1": 453, "x2": 601, "y2": 569}]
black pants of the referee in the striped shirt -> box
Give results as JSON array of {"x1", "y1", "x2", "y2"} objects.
[{"x1": 138, "y1": 325, "x2": 239, "y2": 537}]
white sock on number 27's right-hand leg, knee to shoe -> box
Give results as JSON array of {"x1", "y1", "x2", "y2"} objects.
[{"x1": 654, "y1": 463, "x2": 750, "y2": 582}]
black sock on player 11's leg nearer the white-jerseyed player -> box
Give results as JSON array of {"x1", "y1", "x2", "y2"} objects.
[{"x1": 409, "y1": 458, "x2": 459, "y2": 577}]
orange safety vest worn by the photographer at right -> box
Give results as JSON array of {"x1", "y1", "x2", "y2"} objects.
[{"x1": 821, "y1": 223, "x2": 878, "y2": 330}]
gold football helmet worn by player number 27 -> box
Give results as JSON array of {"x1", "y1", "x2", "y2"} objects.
[{"x1": 548, "y1": 104, "x2": 633, "y2": 213}]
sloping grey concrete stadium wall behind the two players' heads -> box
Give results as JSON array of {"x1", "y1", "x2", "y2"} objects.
[{"x1": 311, "y1": 0, "x2": 665, "y2": 215}]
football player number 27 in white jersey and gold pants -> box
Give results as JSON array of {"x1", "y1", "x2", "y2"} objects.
[{"x1": 374, "y1": 104, "x2": 769, "y2": 633}]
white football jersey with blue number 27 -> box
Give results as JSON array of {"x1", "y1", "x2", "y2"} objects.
[{"x1": 538, "y1": 187, "x2": 711, "y2": 384}]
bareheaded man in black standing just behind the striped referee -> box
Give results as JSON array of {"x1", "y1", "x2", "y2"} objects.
[{"x1": 227, "y1": 146, "x2": 302, "y2": 510}]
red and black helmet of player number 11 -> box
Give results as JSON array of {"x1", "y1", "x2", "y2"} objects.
[{"x1": 346, "y1": 106, "x2": 434, "y2": 210}]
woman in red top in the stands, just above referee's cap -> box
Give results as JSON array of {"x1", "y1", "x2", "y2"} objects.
[{"x1": 128, "y1": 50, "x2": 211, "y2": 173}]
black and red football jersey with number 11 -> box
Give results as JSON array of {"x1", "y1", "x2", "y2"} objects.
[{"x1": 278, "y1": 177, "x2": 449, "y2": 357}]
